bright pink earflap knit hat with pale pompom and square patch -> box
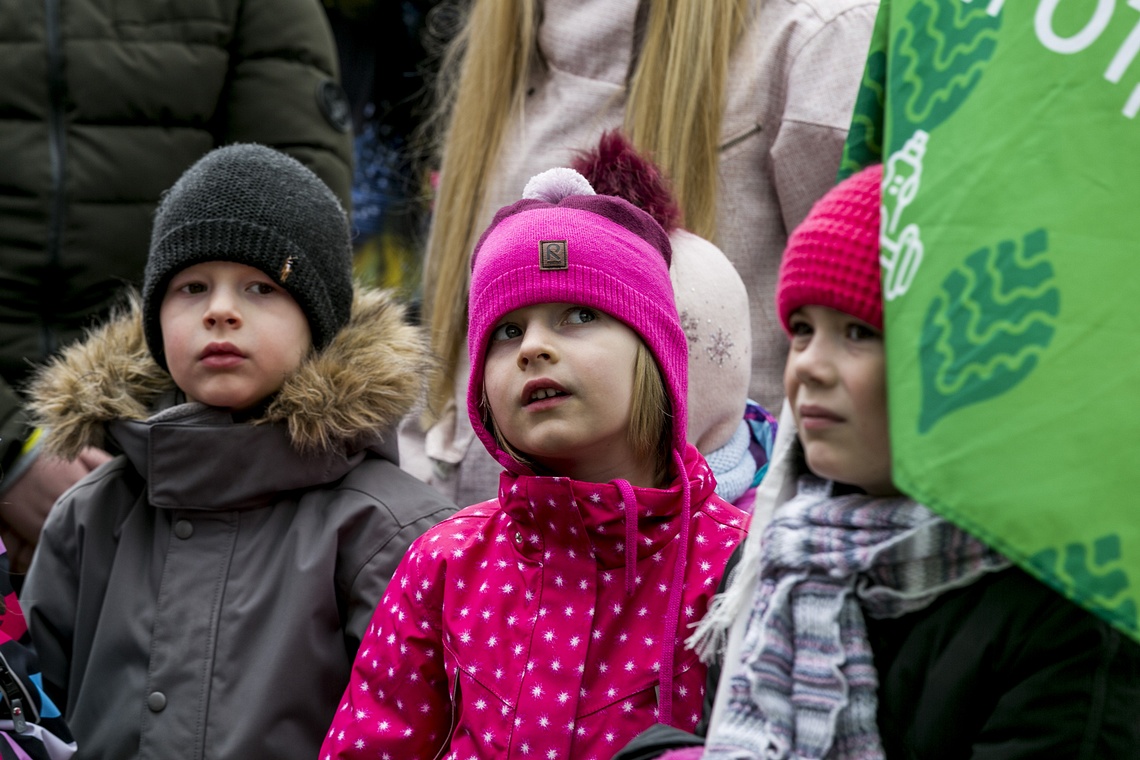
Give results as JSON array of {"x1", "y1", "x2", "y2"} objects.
[{"x1": 467, "y1": 169, "x2": 689, "y2": 474}]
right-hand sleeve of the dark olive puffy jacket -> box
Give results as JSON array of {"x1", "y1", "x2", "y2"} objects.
[{"x1": 220, "y1": 0, "x2": 352, "y2": 209}]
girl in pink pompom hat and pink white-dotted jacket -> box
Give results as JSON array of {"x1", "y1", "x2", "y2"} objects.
[{"x1": 320, "y1": 169, "x2": 746, "y2": 760}]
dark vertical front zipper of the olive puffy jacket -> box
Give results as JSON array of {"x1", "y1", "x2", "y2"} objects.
[{"x1": 41, "y1": 0, "x2": 66, "y2": 356}]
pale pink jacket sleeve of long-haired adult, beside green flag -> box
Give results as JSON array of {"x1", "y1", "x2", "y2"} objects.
[{"x1": 771, "y1": 2, "x2": 878, "y2": 232}]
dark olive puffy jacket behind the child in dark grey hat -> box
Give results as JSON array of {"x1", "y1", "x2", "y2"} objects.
[{"x1": 0, "y1": 0, "x2": 351, "y2": 460}]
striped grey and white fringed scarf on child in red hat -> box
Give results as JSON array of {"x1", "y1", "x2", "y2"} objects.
[{"x1": 705, "y1": 475, "x2": 1009, "y2": 760}]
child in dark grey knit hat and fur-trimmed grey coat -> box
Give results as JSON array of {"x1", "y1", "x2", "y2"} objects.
[{"x1": 23, "y1": 145, "x2": 453, "y2": 760}]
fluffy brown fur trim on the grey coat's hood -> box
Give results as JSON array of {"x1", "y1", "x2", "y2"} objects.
[{"x1": 29, "y1": 287, "x2": 435, "y2": 458}]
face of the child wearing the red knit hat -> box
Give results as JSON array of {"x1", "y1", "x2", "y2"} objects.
[{"x1": 784, "y1": 305, "x2": 897, "y2": 496}]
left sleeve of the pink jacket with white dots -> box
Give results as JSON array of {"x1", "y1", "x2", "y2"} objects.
[{"x1": 319, "y1": 533, "x2": 455, "y2": 760}]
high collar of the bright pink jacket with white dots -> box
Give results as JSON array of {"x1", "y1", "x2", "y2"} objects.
[{"x1": 499, "y1": 446, "x2": 716, "y2": 570}]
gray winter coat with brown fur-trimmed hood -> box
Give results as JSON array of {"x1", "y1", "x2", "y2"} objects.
[{"x1": 23, "y1": 288, "x2": 454, "y2": 760}]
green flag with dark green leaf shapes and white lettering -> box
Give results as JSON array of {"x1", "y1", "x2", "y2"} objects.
[{"x1": 840, "y1": 0, "x2": 1140, "y2": 640}]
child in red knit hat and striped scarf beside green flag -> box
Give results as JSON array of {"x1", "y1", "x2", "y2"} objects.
[{"x1": 619, "y1": 166, "x2": 1140, "y2": 760}]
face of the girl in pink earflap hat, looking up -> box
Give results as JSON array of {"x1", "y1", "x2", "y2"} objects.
[{"x1": 483, "y1": 303, "x2": 652, "y2": 483}]
